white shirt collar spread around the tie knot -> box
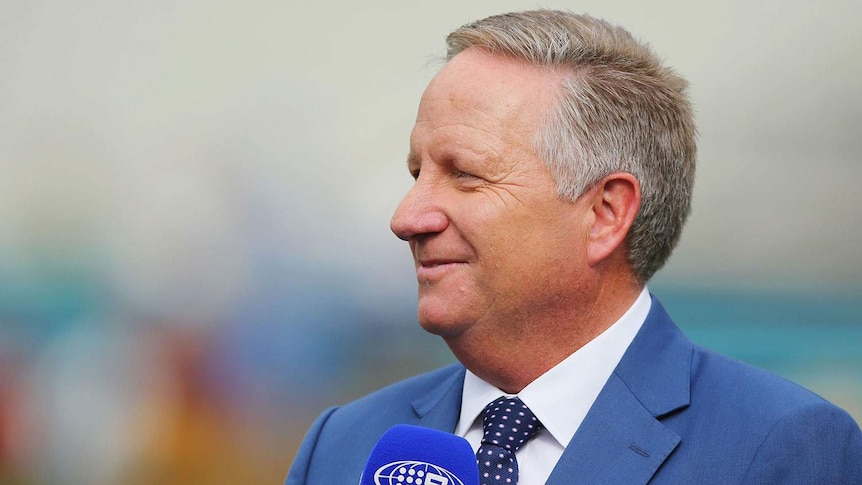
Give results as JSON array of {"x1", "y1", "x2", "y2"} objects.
[{"x1": 455, "y1": 287, "x2": 652, "y2": 447}]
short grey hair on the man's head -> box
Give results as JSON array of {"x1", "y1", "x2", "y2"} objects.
[{"x1": 446, "y1": 10, "x2": 697, "y2": 283}]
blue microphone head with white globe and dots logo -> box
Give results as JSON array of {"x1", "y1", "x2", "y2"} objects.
[{"x1": 360, "y1": 424, "x2": 479, "y2": 485}]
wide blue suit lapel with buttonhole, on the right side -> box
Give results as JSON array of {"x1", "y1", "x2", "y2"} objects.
[{"x1": 547, "y1": 298, "x2": 692, "y2": 485}]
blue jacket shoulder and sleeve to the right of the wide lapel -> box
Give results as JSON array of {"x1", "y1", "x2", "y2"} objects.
[{"x1": 663, "y1": 346, "x2": 862, "y2": 484}]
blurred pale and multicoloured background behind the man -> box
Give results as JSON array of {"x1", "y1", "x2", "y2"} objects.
[{"x1": 0, "y1": 0, "x2": 862, "y2": 485}]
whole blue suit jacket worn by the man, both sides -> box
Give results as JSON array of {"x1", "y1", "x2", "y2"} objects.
[{"x1": 286, "y1": 299, "x2": 862, "y2": 485}]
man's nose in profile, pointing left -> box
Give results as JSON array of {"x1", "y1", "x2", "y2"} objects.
[{"x1": 389, "y1": 174, "x2": 449, "y2": 241}]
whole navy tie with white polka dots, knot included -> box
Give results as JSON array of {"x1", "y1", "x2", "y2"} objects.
[{"x1": 476, "y1": 397, "x2": 542, "y2": 485}]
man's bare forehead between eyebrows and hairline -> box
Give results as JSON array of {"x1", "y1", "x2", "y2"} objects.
[{"x1": 411, "y1": 48, "x2": 562, "y2": 165}]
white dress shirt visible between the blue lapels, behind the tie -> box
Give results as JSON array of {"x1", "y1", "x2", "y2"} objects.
[{"x1": 455, "y1": 287, "x2": 652, "y2": 485}]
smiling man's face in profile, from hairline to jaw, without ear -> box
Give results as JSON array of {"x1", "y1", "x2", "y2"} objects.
[{"x1": 391, "y1": 49, "x2": 588, "y2": 339}]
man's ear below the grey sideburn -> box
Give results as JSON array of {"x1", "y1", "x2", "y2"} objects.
[{"x1": 587, "y1": 172, "x2": 641, "y2": 265}]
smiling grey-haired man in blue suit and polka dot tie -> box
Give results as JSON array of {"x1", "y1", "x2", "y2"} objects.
[{"x1": 287, "y1": 11, "x2": 862, "y2": 485}]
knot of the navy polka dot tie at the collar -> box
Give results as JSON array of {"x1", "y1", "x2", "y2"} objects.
[{"x1": 482, "y1": 397, "x2": 542, "y2": 453}]
